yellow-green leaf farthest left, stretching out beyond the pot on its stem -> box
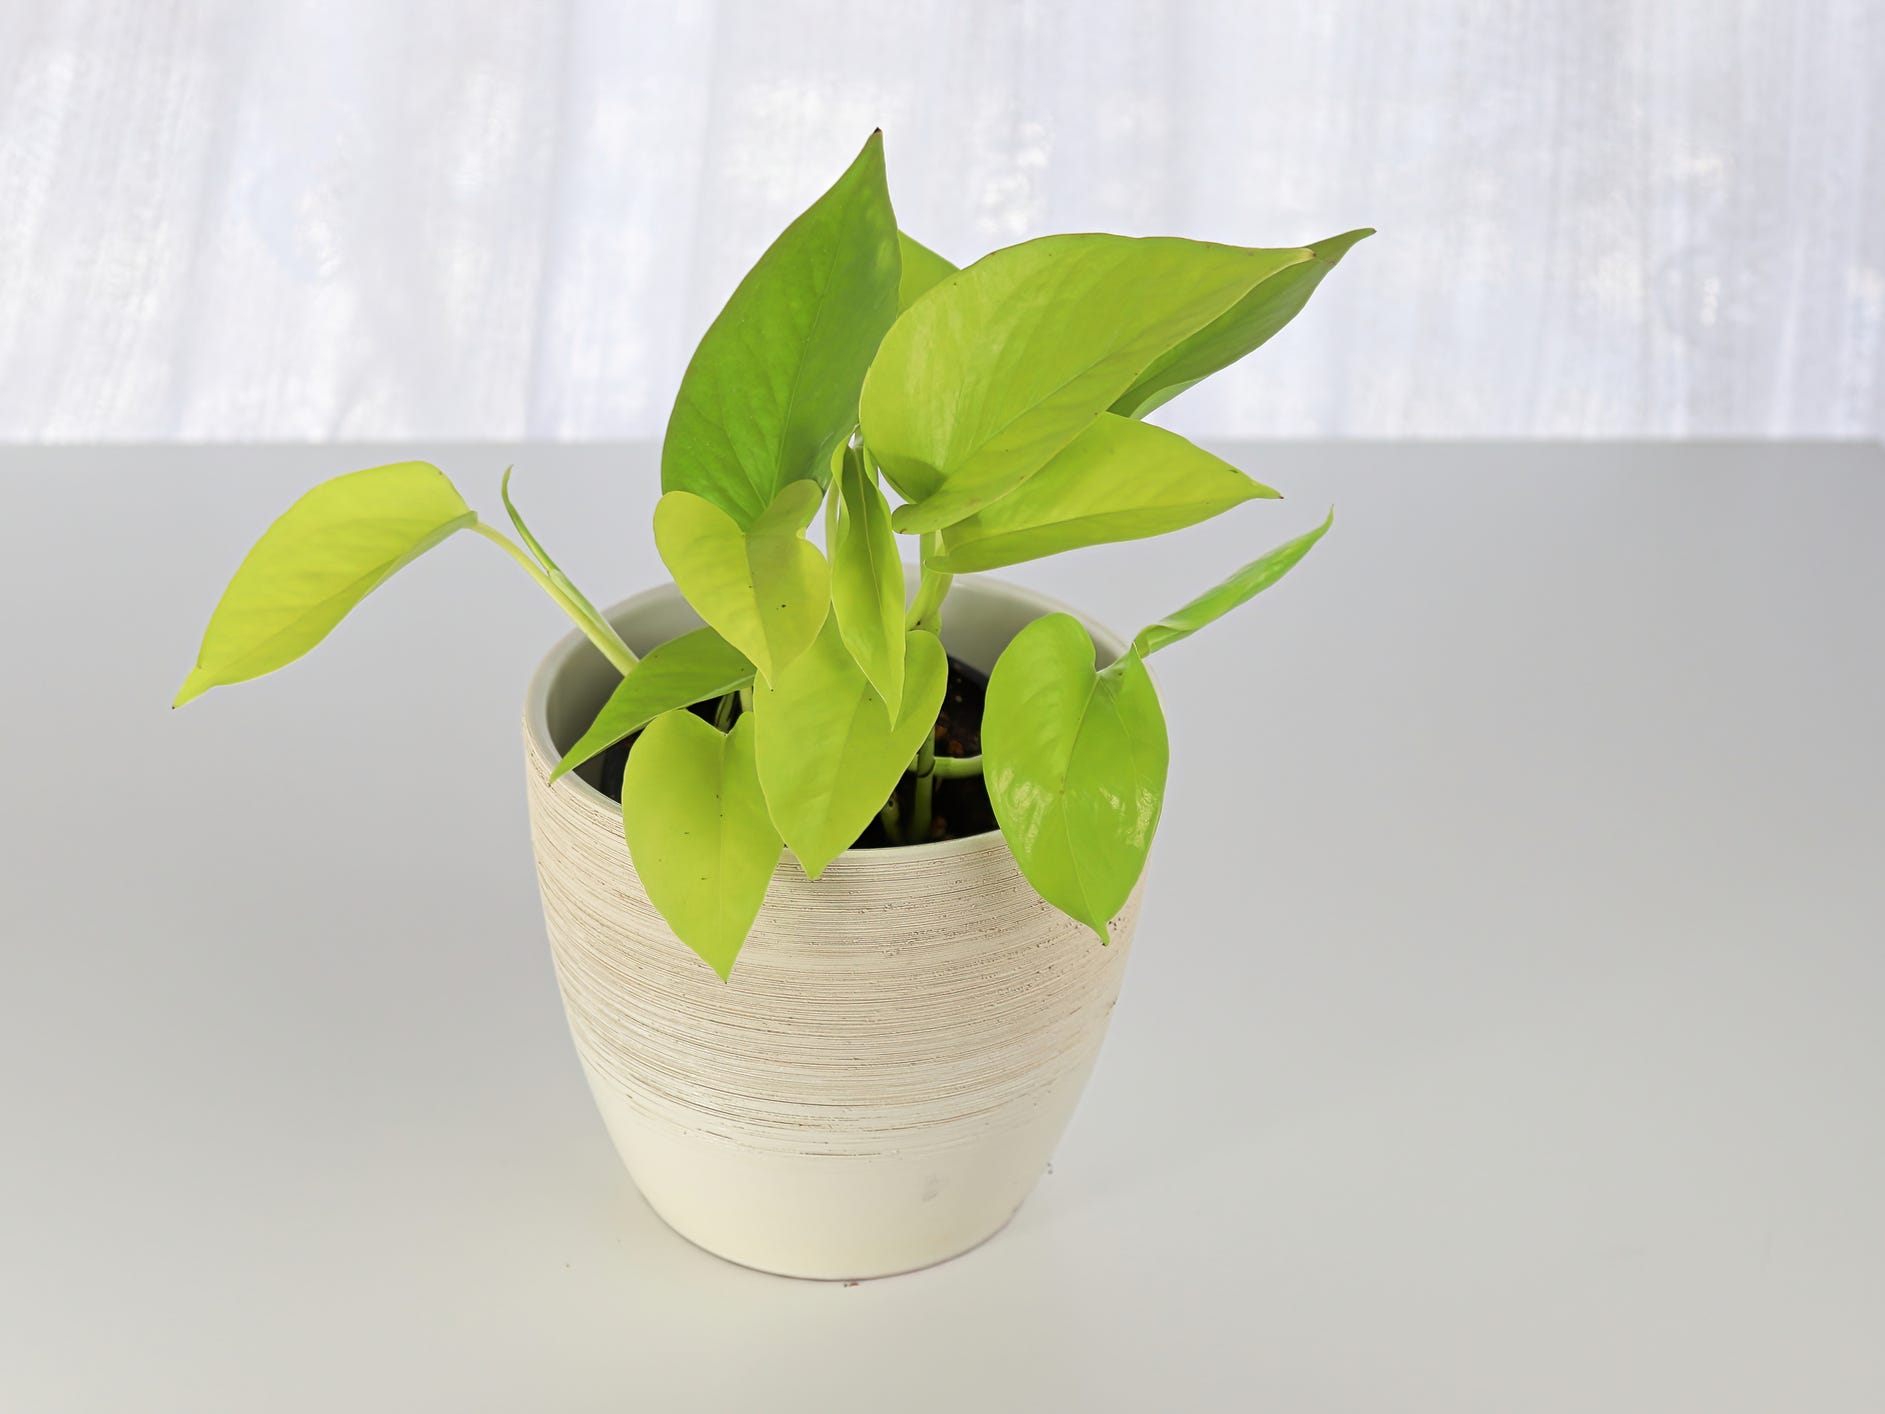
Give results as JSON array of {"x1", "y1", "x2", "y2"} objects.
[{"x1": 172, "y1": 462, "x2": 477, "y2": 707}]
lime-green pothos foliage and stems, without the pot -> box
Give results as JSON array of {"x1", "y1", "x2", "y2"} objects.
[{"x1": 175, "y1": 134, "x2": 1372, "y2": 978}]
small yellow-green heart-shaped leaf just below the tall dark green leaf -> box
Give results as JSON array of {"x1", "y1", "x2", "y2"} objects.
[{"x1": 654, "y1": 481, "x2": 831, "y2": 681}]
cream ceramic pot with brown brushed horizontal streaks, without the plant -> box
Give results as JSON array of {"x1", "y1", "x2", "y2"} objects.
[{"x1": 524, "y1": 577, "x2": 1139, "y2": 1278}]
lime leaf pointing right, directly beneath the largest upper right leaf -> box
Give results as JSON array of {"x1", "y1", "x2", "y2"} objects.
[{"x1": 926, "y1": 413, "x2": 1276, "y2": 575}]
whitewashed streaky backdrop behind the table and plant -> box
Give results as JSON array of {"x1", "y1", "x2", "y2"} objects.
[{"x1": 0, "y1": 0, "x2": 1885, "y2": 441}]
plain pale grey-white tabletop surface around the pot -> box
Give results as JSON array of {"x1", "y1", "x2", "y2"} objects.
[{"x1": 0, "y1": 445, "x2": 1885, "y2": 1414}]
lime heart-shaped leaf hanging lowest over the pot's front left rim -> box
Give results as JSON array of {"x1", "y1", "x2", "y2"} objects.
[{"x1": 622, "y1": 711, "x2": 779, "y2": 982}]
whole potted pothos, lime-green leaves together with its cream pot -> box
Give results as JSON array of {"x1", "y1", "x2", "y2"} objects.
[{"x1": 177, "y1": 134, "x2": 1369, "y2": 1278}]
